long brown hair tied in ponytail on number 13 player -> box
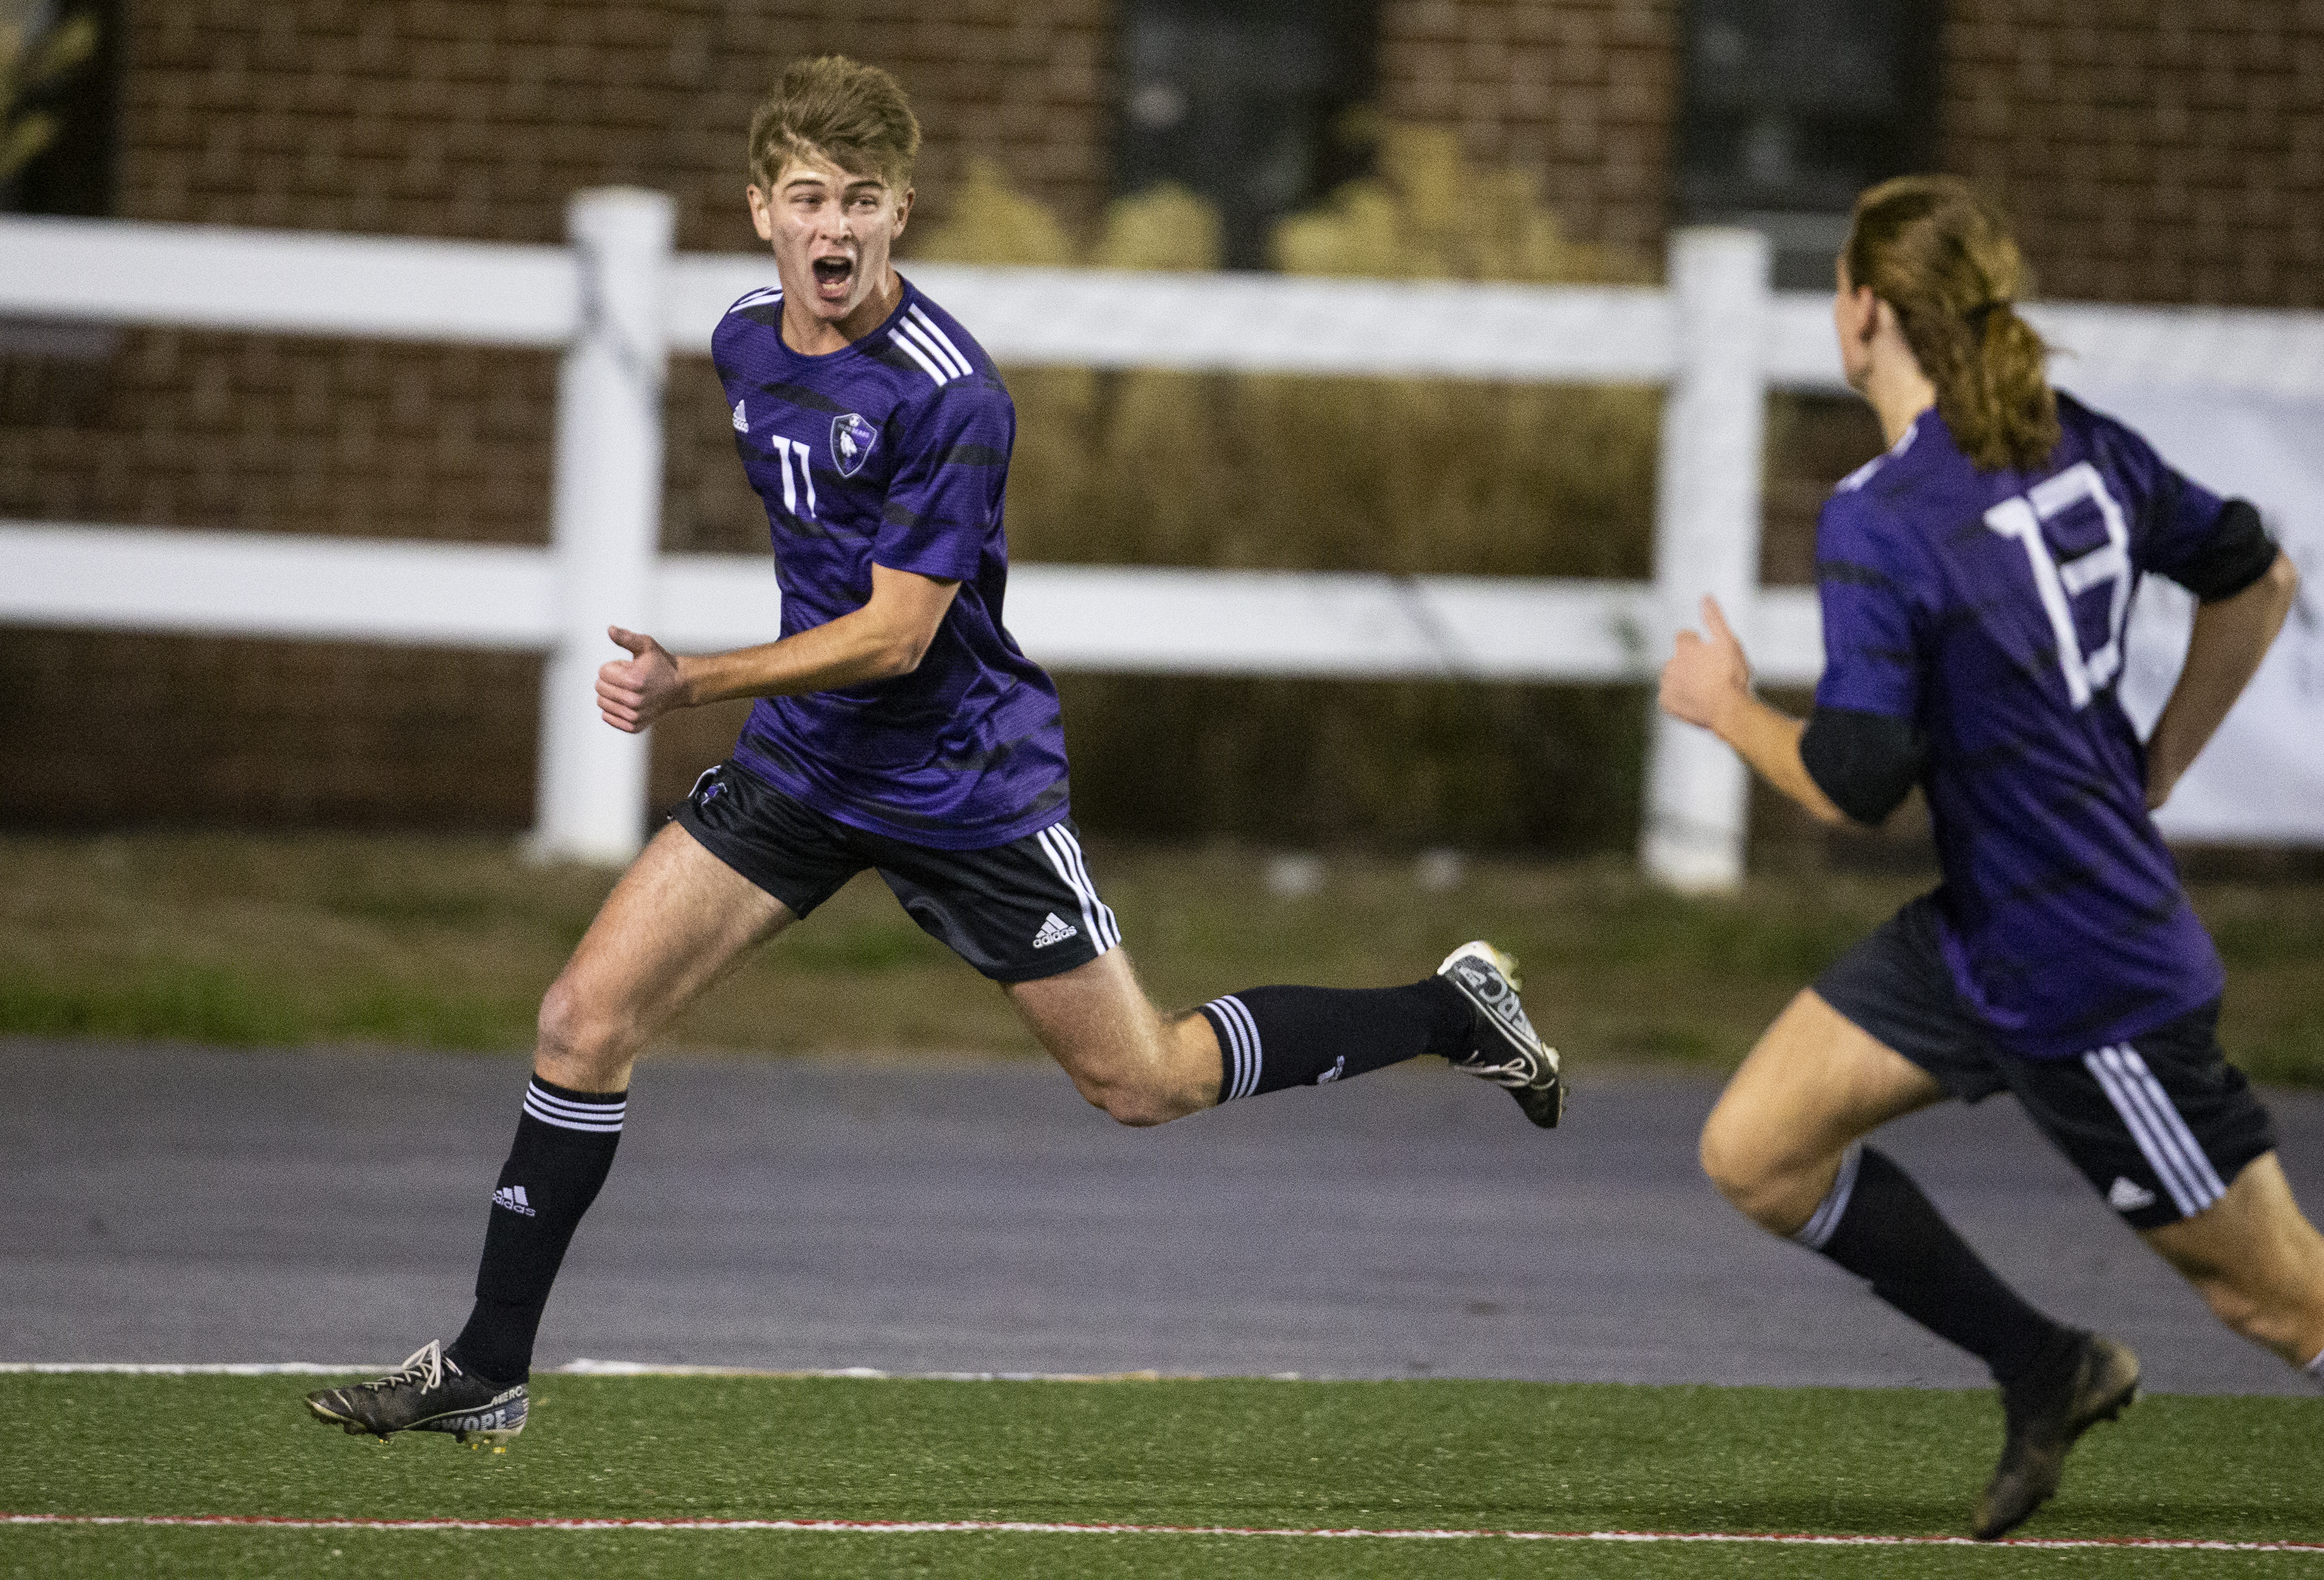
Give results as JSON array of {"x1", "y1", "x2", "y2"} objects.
[{"x1": 1841, "y1": 177, "x2": 2059, "y2": 472}]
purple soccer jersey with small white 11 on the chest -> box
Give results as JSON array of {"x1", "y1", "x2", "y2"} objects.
[{"x1": 711, "y1": 281, "x2": 1067, "y2": 851}]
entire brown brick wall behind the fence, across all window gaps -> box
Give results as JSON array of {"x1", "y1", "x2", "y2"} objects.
[{"x1": 0, "y1": 0, "x2": 2324, "y2": 827}]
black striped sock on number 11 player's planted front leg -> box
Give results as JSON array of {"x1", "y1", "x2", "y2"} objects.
[{"x1": 446, "y1": 1076, "x2": 630, "y2": 1383}]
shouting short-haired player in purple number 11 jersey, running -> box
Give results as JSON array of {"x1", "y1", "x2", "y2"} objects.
[{"x1": 295, "y1": 56, "x2": 1564, "y2": 1448}]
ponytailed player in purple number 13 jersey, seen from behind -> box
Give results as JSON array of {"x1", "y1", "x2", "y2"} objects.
[{"x1": 1662, "y1": 177, "x2": 2324, "y2": 1538}]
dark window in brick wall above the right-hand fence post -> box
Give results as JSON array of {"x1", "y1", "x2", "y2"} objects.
[{"x1": 1675, "y1": 0, "x2": 1943, "y2": 288}]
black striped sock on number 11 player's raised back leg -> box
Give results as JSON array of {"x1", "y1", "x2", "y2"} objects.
[{"x1": 1201, "y1": 976, "x2": 1469, "y2": 1104}]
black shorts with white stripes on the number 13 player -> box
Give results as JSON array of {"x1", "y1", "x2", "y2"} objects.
[{"x1": 1815, "y1": 895, "x2": 2275, "y2": 1229}]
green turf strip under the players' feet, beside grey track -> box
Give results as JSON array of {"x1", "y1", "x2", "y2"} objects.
[{"x1": 0, "y1": 1373, "x2": 2324, "y2": 1578}]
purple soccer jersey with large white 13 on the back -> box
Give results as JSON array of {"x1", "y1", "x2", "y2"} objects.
[{"x1": 1815, "y1": 395, "x2": 2226, "y2": 1060}]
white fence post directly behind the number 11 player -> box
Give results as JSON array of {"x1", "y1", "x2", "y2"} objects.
[{"x1": 532, "y1": 186, "x2": 674, "y2": 862}]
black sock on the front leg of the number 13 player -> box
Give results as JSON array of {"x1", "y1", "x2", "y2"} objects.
[{"x1": 1792, "y1": 1146, "x2": 2082, "y2": 1387}]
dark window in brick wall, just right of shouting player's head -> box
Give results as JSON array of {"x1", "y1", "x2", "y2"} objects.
[{"x1": 1113, "y1": 0, "x2": 1380, "y2": 270}]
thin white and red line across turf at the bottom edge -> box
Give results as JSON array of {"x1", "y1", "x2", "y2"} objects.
[{"x1": 0, "y1": 1515, "x2": 2324, "y2": 1552}]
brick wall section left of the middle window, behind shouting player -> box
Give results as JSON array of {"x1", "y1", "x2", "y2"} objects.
[{"x1": 0, "y1": 0, "x2": 1111, "y2": 827}]
